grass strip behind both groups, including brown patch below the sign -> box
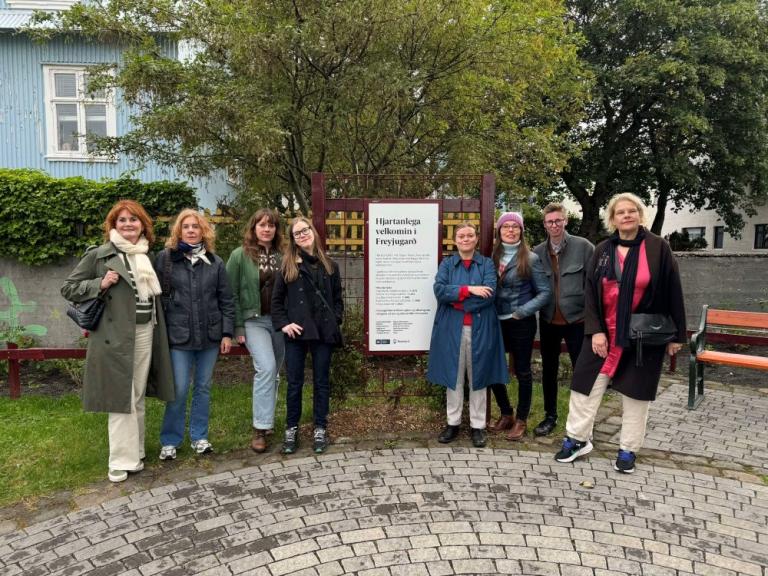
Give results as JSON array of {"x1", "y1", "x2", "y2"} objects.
[{"x1": 0, "y1": 372, "x2": 568, "y2": 506}]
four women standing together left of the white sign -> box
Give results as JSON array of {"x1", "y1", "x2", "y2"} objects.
[{"x1": 61, "y1": 200, "x2": 344, "y2": 482}]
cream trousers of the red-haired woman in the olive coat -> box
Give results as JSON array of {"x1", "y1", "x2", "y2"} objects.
[{"x1": 108, "y1": 322, "x2": 154, "y2": 470}]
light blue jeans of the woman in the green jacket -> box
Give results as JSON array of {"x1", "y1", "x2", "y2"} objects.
[{"x1": 245, "y1": 316, "x2": 285, "y2": 430}]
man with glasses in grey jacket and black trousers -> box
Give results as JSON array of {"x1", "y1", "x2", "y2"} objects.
[{"x1": 533, "y1": 203, "x2": 595, "y2": 436}]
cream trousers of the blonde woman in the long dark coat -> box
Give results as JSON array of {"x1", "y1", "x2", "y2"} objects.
[{"x1": 565, "y1": 374, "x2": 651, "y2": 452}]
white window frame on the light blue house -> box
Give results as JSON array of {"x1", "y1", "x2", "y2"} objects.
[{"x1": 43, "y1": 64, "x2": 117, "y2": 162}]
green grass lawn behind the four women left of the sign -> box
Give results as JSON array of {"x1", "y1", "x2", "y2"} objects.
[{"x1": 0, "y1": 383, "x2": 312, "y2": 506}]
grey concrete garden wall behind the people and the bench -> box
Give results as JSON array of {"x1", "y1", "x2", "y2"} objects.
[{"x1": 0, "y1": 252, "x2": 768, "y2": 347}]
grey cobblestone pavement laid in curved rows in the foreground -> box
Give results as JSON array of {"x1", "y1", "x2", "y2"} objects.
[{"x1": 0, "y1": 384, "x2": 768, "y2": 576}]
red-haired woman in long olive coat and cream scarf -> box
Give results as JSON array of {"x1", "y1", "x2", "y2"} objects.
[{"x1": 61, "y1": 200, "x2": 174, "y2": 482}]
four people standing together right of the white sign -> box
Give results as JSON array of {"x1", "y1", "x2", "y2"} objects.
[{"x1": 427, "y1": 193, "x2": 686, "y2": 473}]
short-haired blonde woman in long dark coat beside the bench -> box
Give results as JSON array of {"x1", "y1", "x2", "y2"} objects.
[{"x1": 555, "y1": 193, "x2": 686, "y2": 474}]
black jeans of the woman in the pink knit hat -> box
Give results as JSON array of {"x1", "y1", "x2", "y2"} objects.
[{"x1": 491, "y1": 316, "x2": 536, "y2": 420}]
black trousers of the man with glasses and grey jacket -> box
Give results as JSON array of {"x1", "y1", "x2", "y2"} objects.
[{"x1": 539, "y1": 320, "x2": 584, "y2": 419}]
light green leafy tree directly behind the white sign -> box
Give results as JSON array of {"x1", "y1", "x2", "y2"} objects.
[{"x1": 28, "y1": 0, "x2": 584, "y2": 212}]
